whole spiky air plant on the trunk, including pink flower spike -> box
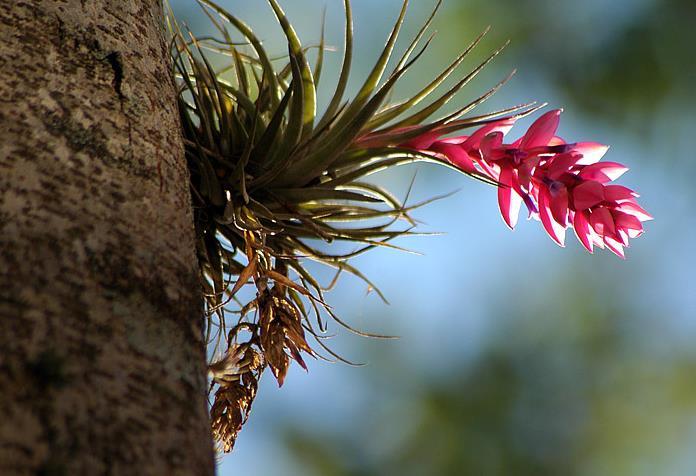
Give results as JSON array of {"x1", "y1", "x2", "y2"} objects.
[{"x1": 170, "y1": 0, "x2": 650, "y2": 452}]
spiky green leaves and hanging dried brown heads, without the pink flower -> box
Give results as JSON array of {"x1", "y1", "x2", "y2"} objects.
[{"x1": 170, "y1": 0, "x2": 536, "y2": 452}]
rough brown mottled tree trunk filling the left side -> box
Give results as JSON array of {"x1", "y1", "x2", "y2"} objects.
[{"x1": 0, "y1": 0, "x2": 214, "y2": 476}]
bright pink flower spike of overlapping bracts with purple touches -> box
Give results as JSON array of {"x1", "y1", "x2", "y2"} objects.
[{"x1": 401, "y1": 109, "x2": 652, "y2": 258}]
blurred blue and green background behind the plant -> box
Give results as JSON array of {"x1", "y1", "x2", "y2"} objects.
[{"x1": 172, "y1": 0, "x2": 696, "y2": 476}]
